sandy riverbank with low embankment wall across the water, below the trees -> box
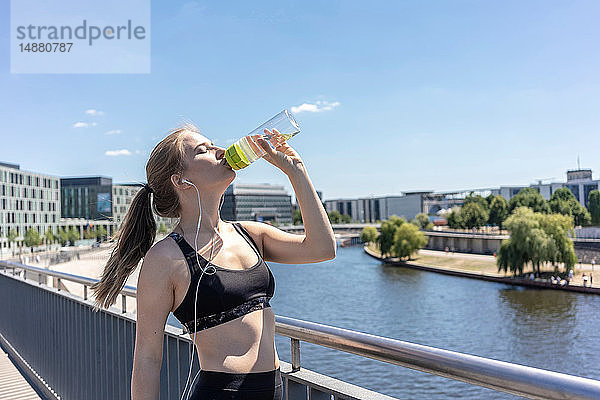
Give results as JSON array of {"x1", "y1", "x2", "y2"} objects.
[{"x1": 363, "y1": 246, "x2": 600, "y2": 294}]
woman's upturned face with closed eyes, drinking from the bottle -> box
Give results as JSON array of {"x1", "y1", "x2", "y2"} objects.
[{"x1": 182, "y1": 132, "x2": 235, "y2": 189}]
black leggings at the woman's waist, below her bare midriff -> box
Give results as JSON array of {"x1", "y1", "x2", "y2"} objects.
[{"x1": 190, "y1": 367, "x2": 283, "y2": 400}]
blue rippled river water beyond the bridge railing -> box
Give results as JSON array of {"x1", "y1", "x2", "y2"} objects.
[{"x1": 169, "y1": 246, "x2": 600, "y2": 399}]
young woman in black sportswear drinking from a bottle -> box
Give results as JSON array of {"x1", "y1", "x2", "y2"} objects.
[{"x1": 92, "y1": 124, "x2": 336, "y2": 400}]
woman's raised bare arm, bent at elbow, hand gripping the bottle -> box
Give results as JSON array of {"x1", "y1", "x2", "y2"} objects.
[{"x1": 243, "y1": 131, "x2": 336, "y2": 264}]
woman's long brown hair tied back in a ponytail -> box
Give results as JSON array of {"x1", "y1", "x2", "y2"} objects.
[{"x1": 90, "y1": 123, "x2": 199, "y2": 311}]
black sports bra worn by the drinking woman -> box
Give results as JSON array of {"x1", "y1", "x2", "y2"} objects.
[{"x1": 169, "y1": 222, "x2": 275, "y2": 333}]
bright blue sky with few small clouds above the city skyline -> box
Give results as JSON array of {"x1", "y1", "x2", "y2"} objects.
[{"x1": 0, "y1": 0, "x2": 600, "y2": 199}]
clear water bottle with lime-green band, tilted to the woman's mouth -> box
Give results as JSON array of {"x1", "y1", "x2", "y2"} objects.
[{"x1": 225, "y1": 109, "x2": 300, "y2": 170}]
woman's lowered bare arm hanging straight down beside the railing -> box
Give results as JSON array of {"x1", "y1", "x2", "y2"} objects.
[{"x1": 131, "y1": 245, "x2": 174, "y2": 400}]
